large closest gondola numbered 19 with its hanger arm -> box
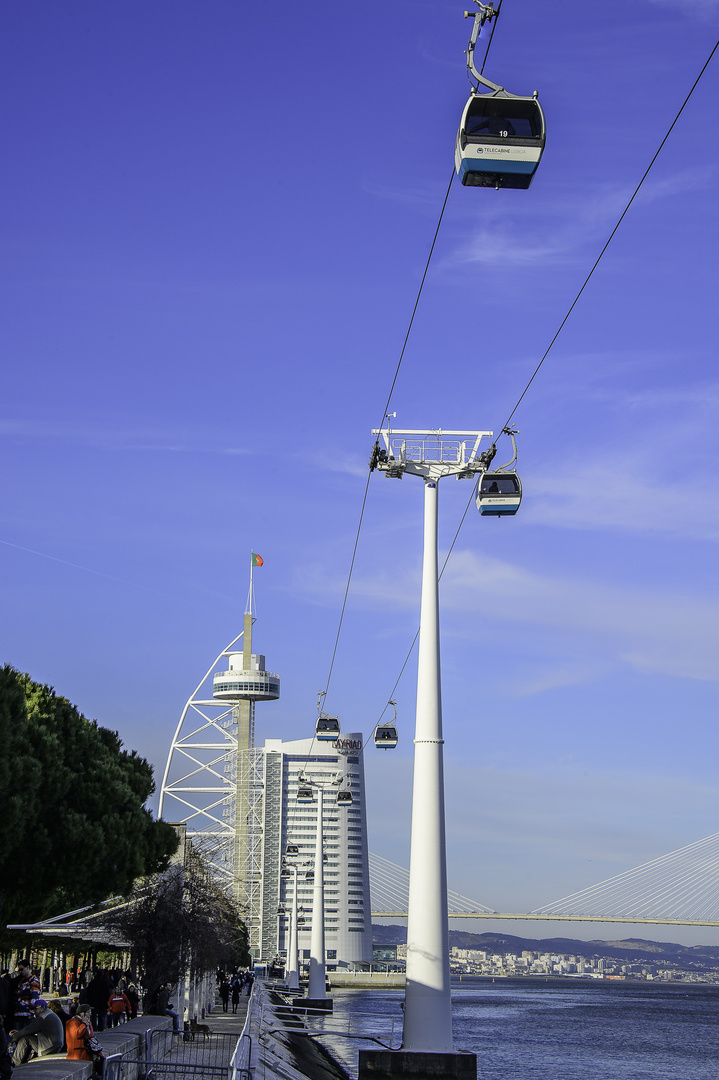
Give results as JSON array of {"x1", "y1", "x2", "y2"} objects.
[{"x1": 455, "y1": 0, "x2": 546, "y2": 189}]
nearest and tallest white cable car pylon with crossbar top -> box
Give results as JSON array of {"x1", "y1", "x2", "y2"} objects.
[{"x1": 372, "y1": 427, "x2": 492, "y2": 1053}]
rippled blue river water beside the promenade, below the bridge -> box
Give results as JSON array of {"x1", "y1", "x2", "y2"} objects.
[{"x1": 311, "y1": 976, "x2": 719, "y2": 1080}]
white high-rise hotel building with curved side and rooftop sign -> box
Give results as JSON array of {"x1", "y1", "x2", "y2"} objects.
[{"x1": 255, "y1": 733, "x2": 372, "y2": 971}]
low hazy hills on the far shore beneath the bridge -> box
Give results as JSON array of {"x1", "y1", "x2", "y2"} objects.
[{"x1": 372, "y1": 926, "x2": 719, "y2": 969}]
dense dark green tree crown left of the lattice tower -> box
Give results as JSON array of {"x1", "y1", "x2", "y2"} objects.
[{"x1": 0, "y1": 665, "x2": 177, "y2": 928}]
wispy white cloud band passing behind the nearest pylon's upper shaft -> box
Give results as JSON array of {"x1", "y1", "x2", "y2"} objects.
[{"x1": 304, "y1": 551, "x2": 719, "y2": 697}]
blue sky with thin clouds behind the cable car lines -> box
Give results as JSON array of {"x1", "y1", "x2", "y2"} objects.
[{"x1": 0, "y1": 0, "x2": 719, "y2": 942}]
